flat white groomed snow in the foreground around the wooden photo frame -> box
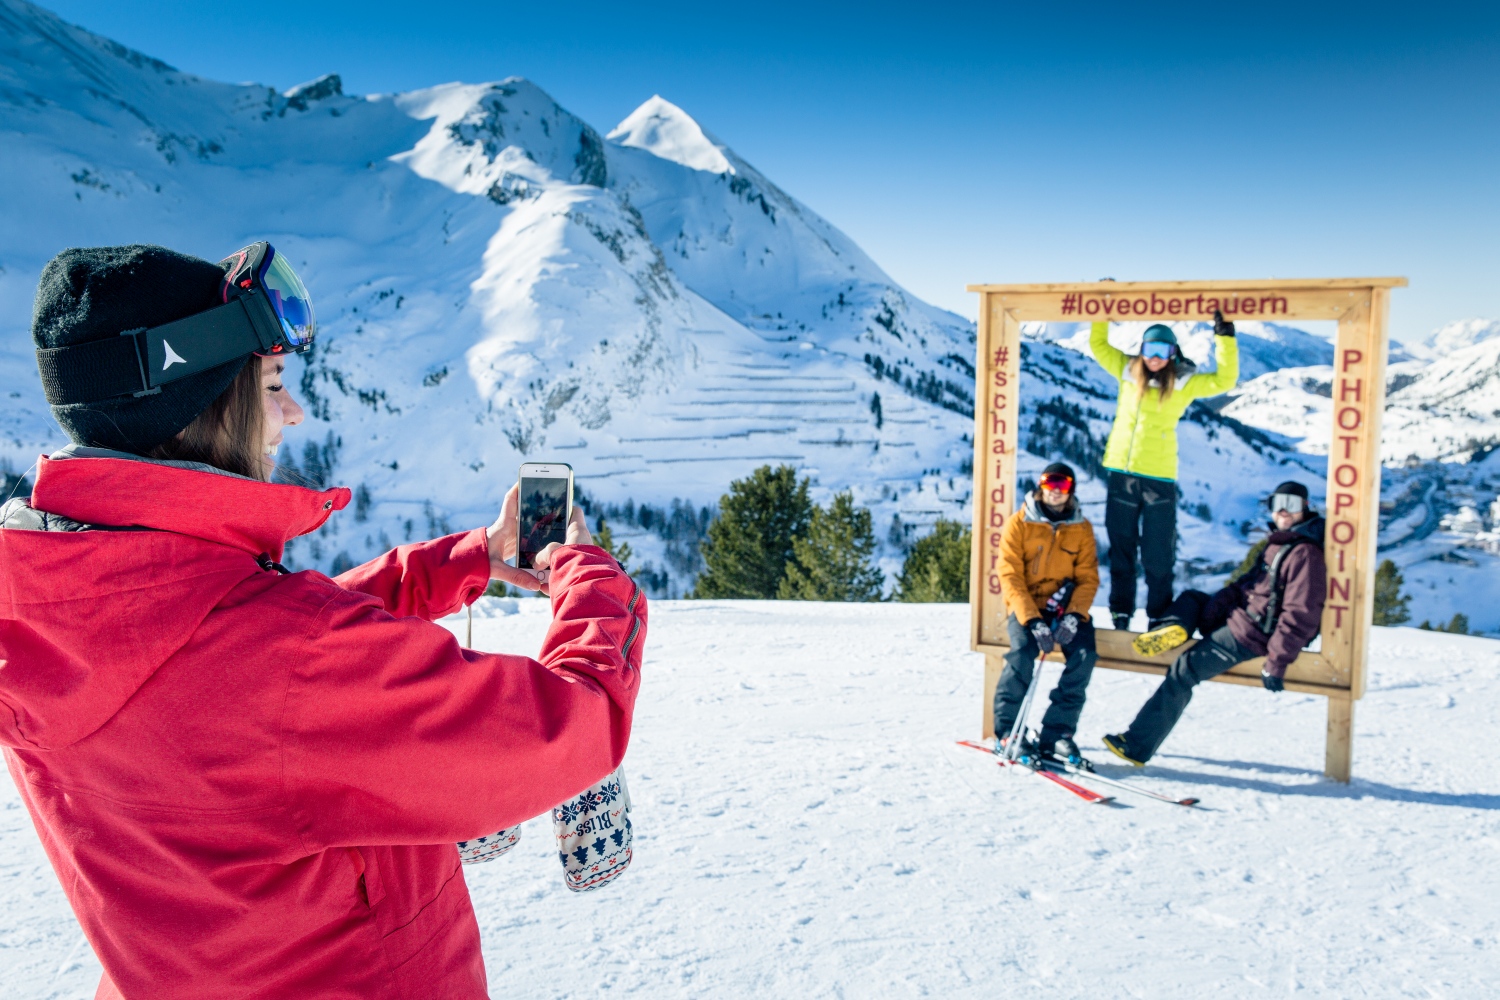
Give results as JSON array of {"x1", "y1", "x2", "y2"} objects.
[{"x1": 0, "y1": 600, "x2": 1500, "y2": 1000}]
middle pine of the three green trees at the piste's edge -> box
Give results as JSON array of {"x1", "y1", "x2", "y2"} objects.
[{"x1": 777, "y1": 490, "x2": 885, "y2": 601}]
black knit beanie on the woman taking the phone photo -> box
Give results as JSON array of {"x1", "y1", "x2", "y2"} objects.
[{"x1": 32, "y1": 244, "x2": 251, "y2": 454}]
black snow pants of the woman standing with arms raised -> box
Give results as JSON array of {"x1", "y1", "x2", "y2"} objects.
[{"x1": 1104, "y1": 469, "x2": 1178, "y2": 619}]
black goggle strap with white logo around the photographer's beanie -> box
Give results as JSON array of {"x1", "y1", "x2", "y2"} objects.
[{"x1": 36, "y1": 294, "x2": 279, "y2": 406}]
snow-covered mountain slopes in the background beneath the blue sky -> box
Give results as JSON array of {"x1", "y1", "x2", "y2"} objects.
[{"x1": 0, "y1": 0, "x2": 1500, "y2": 631}]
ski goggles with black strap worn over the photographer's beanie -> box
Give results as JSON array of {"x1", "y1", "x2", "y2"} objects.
[{"x1": 36, "y1": 241, "x2": 318, "y2": 406}]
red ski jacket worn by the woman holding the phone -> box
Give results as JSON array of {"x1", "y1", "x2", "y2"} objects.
[{"x1": 0, "y1": 457, "x2": 647, "y2": 1000}]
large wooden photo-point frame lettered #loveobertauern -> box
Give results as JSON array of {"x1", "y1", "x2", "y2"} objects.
[{"x1": 969, "y1": 277, "x2": 1407, "y2": 781}]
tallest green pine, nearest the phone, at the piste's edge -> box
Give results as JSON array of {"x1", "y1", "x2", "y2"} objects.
[{"x1": 693, "y1": 465, "x2": 813, "y2": 600}]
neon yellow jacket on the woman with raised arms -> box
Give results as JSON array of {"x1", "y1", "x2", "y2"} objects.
[{"x1": 1089, "y1": 322, "x2": 1239, "y2": 480}]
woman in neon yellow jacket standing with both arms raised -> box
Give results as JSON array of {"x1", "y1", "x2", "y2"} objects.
[{"x1": 1089, "y1": 310, "x2": 1239, "y2": 630}]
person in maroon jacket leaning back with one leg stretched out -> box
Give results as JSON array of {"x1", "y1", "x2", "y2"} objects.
[{"x1": 1104, "y1": 483, "x2": 1328, "y2": 766}]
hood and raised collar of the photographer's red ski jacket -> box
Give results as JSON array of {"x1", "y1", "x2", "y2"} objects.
[{"x1": 0, "y1": 450, "x2": 350, "y2": 750}]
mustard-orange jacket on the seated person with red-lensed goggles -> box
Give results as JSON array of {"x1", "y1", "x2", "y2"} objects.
[{"x1": 1001, "y1": 492, "x2": 1100, "y2": 624}]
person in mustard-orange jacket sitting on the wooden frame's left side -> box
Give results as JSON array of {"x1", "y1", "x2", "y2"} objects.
[{"x1": 995, "y1": 462, "x2": 1100, "y2": 766}]
